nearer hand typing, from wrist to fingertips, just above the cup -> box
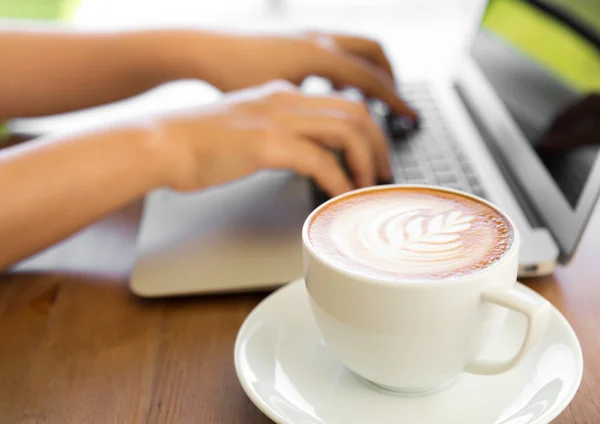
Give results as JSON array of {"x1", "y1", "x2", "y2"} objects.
[{"x1": 158, "y1": 81, "x2": 391, "y2": 196}]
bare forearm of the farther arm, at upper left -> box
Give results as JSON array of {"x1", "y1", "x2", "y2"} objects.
[{"x1": 0, "y1": 27, "x2": 212, "y2": 118}]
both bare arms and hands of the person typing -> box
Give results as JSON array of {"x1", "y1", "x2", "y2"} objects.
[{"x1": 0, "y1": 26, "x2": 417, "y2": 269}]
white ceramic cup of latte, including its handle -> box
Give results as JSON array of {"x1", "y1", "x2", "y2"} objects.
[{"x1": 302, "y1": 185, "x2": 550, "y2": 395}]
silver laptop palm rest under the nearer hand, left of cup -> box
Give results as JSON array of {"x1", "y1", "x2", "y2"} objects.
[{"x1": 131, "y1": 171, "x2": 313, "y2": 296}]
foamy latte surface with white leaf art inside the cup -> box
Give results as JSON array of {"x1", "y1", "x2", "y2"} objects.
[{"x1": 308, "y1": 187, "x2": 514, "y2": 280}]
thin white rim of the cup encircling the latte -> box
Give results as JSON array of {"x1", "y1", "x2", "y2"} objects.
[{"x1": 302, "y1": 184, "x2": 521, "y2": 288}]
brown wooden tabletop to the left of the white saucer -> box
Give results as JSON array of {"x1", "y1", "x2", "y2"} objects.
[{"x1": 0, "y1": 274, "x2": 270, "y2": 423}]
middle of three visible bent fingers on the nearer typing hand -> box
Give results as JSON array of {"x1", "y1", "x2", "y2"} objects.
[{"x1": 284, "y1": 113, "x2": 376, "y2": 187}]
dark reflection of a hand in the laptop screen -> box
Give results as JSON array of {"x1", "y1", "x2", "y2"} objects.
[{"x1": 539, "y1": 93, "x2": 600, "y2": 153}]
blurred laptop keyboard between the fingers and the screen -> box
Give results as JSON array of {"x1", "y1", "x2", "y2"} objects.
[{"x1": 388, "y1": 84, "x2": 487, "y2": 202}]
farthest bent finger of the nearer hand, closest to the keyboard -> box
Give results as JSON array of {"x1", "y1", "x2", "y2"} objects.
[{"x1": 274, "y1": 95, "x2": 392, "y2": 181}]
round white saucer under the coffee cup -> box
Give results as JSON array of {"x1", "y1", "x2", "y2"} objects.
[{"x1": 235, "y1": 280, "x2": 583, "y2": 424}]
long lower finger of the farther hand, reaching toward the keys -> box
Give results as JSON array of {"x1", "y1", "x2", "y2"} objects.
[{"x1": 317, "y1": 50, "x2": 418, "y2": 122}]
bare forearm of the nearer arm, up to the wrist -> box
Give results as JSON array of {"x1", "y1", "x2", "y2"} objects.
[{"x1": 0, "y1": 121, "x2": 164, "y2": 269}]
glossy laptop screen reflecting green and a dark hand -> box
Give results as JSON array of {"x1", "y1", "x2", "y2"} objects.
[{"x1": 472, "y1": 0, "x2": 600, "y2": 210}]
